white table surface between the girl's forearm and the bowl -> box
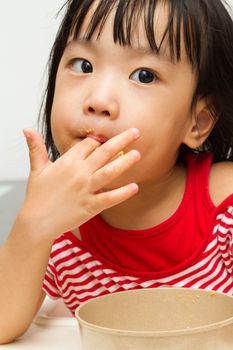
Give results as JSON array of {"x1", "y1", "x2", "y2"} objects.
[{"x1": 0, "y1": 300, "x2": 82, "y2": 350}]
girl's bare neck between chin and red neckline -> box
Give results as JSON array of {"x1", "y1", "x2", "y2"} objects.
[{"x1": 101, "y1": 165, "x2": 186, "y2": 230}]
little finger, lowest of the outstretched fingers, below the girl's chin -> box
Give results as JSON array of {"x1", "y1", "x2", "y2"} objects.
[{"x1": 95, "y1": 183, "x2": 139, "y2": 213}]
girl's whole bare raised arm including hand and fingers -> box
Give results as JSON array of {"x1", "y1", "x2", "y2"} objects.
[{"x1": 0, "y1": 129, "x2": 140, "y2": 344}]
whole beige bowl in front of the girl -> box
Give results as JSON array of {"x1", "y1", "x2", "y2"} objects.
[{"x1": 75, "y1": 288, "x2": 233, "y2": 350}]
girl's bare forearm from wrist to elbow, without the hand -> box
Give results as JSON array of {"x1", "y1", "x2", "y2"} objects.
[{"x1": 0, "y1": 215, "x2": 50, "y2": 344}]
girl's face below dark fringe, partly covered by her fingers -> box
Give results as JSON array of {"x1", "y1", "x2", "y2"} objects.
[{"x1": 51, "y1": 5, "x2": 196, "y2": 186}]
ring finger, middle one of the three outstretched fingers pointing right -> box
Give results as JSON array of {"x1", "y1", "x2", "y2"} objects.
[{"x1": 91, "y1": 150, "x2": 141, "y2": 192}]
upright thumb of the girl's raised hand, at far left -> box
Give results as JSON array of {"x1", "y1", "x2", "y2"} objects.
[{"x1": 23, "y1": 129, "x2": 49, "y2": 170}]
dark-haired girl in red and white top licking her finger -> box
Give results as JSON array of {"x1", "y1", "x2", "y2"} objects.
[{"x1": 0, "y1": 0, "x2": 233, "y2": 343}]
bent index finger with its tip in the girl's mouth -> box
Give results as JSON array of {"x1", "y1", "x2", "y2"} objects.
[{"x1": 67, "y1": 137, "x2": 100, "y2": 160}]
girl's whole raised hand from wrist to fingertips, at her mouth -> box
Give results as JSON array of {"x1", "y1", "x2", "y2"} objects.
[{"x1": 23, "y1": 128, "x2": 140, "y2": 238}]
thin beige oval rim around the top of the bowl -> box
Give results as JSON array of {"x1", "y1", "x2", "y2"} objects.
[{"x1": 75, "y1": 287, "x2": 233, "y2": 337}]
